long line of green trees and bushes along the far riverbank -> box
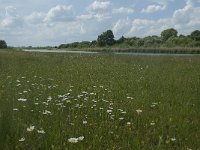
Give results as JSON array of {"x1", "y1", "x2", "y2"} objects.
[{"x1": 59, "y1": 28, "x2": 200, "y2": 48}]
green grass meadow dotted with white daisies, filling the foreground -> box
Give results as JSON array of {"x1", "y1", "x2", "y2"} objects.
[{"x1": 0, "y1": 50, "x2": 200, "y2": 150}]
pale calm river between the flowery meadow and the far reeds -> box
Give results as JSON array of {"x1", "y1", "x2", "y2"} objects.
[{"x1": 23, "y1": 49, "x2": 200, "y2": 56}]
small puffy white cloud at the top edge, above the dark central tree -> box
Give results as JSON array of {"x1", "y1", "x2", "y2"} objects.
[{"x1": 88, "y1": 1, "x2": 111, "y2": 11}]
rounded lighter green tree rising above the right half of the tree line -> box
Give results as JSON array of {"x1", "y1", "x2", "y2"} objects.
[{"x1": 161, "y1": 28, "x2": 178, "y2": 42}]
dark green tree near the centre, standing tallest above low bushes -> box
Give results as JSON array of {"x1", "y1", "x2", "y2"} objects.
[{"x1": 97, "y1": 30, "x2": 115, "y2": 46}]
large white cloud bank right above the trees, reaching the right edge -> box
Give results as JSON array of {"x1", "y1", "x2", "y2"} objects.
[{"x1": 113, "y1": 0, "x2": 200, "y2": 37}]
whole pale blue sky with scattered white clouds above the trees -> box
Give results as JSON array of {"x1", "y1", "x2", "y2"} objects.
[{"x1": 0, "y1": 0, "x2": 200, "y2": 46}]
